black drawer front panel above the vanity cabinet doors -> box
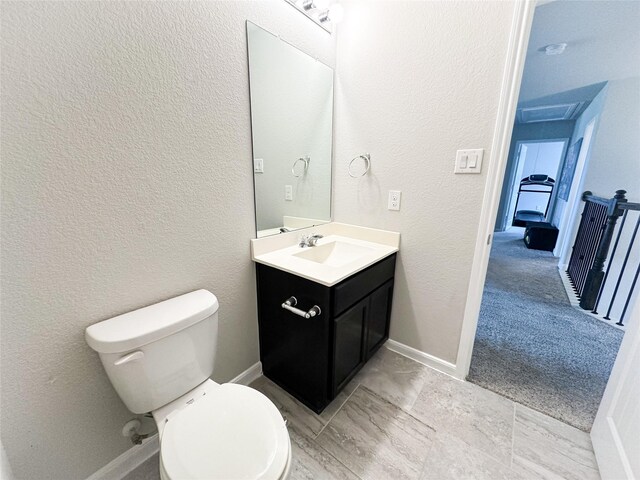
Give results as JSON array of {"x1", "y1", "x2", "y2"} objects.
[{"x1": 333, "y1": 253, "x2": 397, "y2": 315}]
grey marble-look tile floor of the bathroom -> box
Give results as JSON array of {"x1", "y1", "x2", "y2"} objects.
[{"x1": 125, "y1": 348, "x2": 600, "y2": 480}]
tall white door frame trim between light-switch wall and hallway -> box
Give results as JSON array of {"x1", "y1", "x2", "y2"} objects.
[{"x1": 455, "y1": 0, "x2": 539, "y2": 380}]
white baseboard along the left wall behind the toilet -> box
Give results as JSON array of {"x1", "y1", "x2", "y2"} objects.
[{"x1": 87, "y1": 362, "x2": 262, "y2": 480}]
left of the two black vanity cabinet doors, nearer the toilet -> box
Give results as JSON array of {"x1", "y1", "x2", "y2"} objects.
[{"x1": 332, "y1": 297, "x2": 369, "y2": 396}]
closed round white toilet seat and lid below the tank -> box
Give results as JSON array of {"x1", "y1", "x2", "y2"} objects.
[{"x1": 160, "y1": 384, "x2": 290, "y2": 480}]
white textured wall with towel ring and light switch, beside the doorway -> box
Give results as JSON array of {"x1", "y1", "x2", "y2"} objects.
[{"x1": 334, "y1": 1, "x2": 513, "y2": 363}]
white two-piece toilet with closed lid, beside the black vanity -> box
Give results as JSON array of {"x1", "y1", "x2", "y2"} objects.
[{"x1": 85, "y1": 290, "x2": 291, "y2": 480}]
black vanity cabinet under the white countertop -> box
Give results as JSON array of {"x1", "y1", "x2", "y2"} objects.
[{"x1": 256, "y1": 253, "x2": 396, "y2": 413}]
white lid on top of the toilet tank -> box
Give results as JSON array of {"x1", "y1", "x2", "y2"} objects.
[{"x1": 85, "y1": 290, "x2": 218, "y2": 353}]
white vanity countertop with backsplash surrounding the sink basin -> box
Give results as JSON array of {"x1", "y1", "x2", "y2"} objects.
[{"x1": 251, "y1": 222, "x2": 400, "y2": 287}]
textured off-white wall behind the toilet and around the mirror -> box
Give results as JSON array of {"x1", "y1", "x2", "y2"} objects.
[{"x1": 1, "y1": 0, "x2": 335, "y2": 480}]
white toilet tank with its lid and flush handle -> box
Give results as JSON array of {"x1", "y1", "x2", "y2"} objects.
[{"x1": 85, "y1": 290, "x2": 218, "y2": 413}]
